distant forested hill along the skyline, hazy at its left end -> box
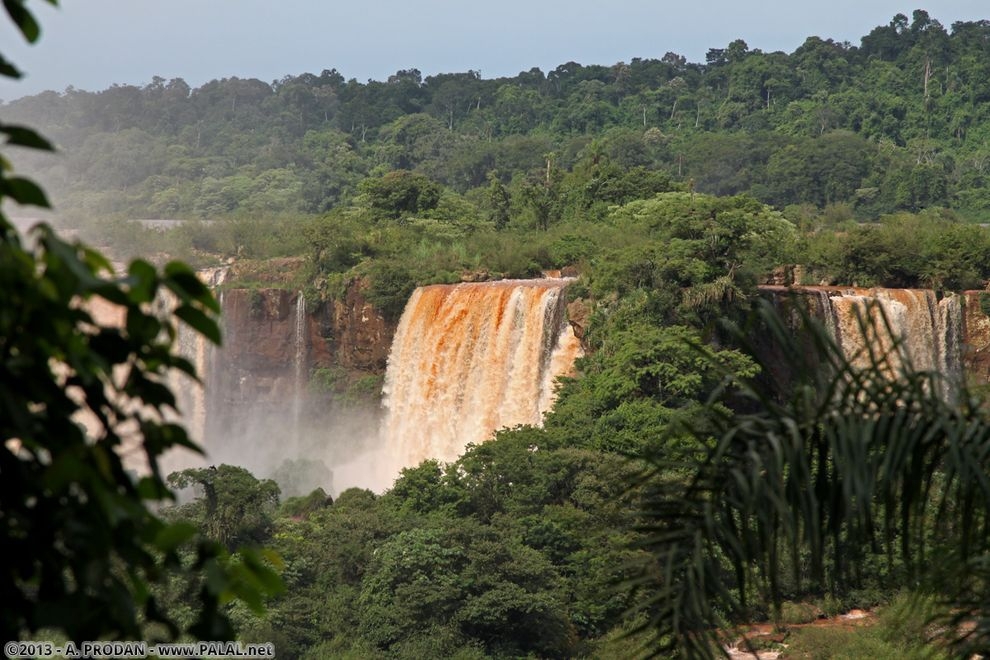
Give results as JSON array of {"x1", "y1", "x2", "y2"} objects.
[{"x1": 0, "y1": 10, "x2": 990, "y2": 224}]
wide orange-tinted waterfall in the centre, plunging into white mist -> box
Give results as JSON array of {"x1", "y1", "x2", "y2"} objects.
[{"x1": 383, "y1": 279, "x2": 581, "y2": 467}]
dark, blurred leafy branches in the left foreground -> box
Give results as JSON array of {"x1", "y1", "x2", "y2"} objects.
[{"x1": 0, "y1": 0, "x2": 278, "y2": 641}]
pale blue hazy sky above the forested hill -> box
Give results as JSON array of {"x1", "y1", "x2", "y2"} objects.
[{"x1": 0, "y1": 0, "x2": 990, "y2": 100}]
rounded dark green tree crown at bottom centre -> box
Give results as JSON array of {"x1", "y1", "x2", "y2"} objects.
[{"x1": 359, "y1": 519, "x2": 575, "y2": 657}]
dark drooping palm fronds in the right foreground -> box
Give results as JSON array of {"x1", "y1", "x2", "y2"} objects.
[{"x1": 640, "y1": 301, "x2": 990, "y2": 658}]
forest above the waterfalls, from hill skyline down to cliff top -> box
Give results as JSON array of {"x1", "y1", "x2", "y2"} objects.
[{"x1": 11, "y1": 10, "x2": 990, "y2": 296}]
